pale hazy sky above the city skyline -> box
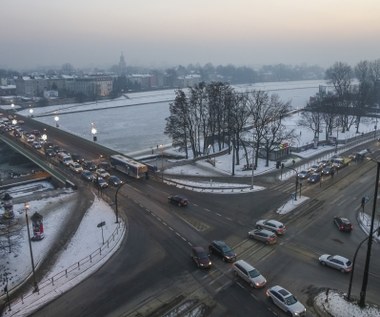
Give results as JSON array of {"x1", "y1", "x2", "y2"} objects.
[{"x1": 0, "y1": 0, "x2": 380, "y2": 69}]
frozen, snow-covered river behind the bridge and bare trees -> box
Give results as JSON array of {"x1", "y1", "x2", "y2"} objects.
[{"x1": 17, "y1": 80, "x2": 326, "y2": 154}]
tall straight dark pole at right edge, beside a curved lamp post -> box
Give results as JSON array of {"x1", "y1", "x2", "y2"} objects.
[{"x1": 359, "y1": 161, "x2": 380, "y2": 307}]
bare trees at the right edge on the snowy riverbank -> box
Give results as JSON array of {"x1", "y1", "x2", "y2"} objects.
[{"x1": 298, "y1": 59, "x2": 380, "y2": 140}]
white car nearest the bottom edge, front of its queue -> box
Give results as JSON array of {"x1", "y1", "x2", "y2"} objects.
[{"x1": 266, "y1": 285, "x2": 306, "y2": 317}]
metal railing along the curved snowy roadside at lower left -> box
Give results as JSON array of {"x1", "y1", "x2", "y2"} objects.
[{"x1": 3, "y1": 222, "x2": 126, "y2": 316}]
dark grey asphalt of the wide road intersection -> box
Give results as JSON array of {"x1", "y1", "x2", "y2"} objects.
[{"x1": 2, "y1": 115, "x2": 380, "y2": 317}]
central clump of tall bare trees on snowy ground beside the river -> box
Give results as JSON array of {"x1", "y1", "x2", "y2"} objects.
[{"x1": 165, "y1": 82, "x2": 295, "y2": 166}]
